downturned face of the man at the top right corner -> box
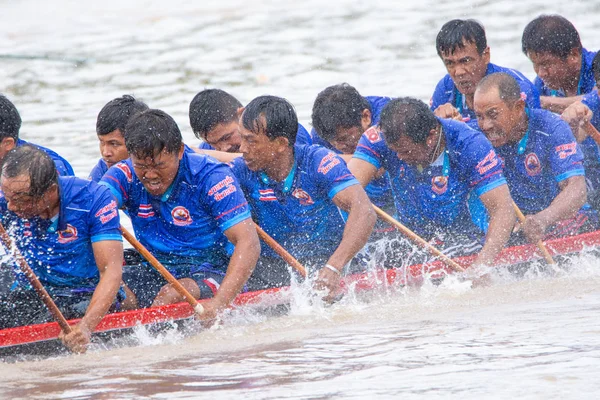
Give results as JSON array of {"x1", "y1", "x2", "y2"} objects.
[{"x1": 527, "y1": 52, "x2": 581, "y2": 90}]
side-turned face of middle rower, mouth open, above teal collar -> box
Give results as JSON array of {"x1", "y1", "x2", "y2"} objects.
[{"x1": 240, "y1": 117, "x2": 292, "y2": 171}]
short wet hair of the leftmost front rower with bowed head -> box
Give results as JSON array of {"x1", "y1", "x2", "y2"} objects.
[{"x1": 2, "y1": 144, "x2": 58, "y2": 198}]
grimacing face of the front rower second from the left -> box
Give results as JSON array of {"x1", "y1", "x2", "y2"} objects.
[{"x1": 129, "y1": 145, "x2": 184, "y2": 196}]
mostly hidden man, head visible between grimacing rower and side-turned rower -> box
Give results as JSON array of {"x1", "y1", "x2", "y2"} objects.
[{"x1": 190, "y1": 89, "x2": 310, "y2": 152}]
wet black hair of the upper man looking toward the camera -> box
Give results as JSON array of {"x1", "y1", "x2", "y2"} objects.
[{"x1": 435, "y1": 19, "x2": 487, "y2": 58}]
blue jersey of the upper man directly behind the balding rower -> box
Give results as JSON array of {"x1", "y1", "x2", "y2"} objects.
[{"x1": 431, "y1": 63, "x2": 541, "y2": 129}]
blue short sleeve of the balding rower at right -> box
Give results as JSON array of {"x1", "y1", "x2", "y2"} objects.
[{"x1": 549, "y1": 117, "x2": 585, "y2": 182}]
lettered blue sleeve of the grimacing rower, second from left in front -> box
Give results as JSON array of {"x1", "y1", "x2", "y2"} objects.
[{"x1": 201, "y1": 160, "x2": 250, "y2": 232}]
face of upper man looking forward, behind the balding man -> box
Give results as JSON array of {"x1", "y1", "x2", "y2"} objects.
[{"x1": 442, "y1": 41, "x2": 490, "y2": 94}]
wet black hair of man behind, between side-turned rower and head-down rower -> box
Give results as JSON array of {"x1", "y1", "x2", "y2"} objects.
[{"x1": 312, "y1": 83, "x2": 372, "y2": 142}]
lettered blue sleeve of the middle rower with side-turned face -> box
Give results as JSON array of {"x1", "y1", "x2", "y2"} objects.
[{"x1": 311, "y1": 148, "x2": 359, "y2": 199}]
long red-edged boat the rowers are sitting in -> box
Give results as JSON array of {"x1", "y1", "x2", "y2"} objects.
[{"x1": 0, "y1": 231, "x2": 600, "y2": 359}]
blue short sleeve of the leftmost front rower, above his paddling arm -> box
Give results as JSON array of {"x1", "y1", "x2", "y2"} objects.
[{"x1": 89, "y1": 183, "x2": 123, "y2": 243}]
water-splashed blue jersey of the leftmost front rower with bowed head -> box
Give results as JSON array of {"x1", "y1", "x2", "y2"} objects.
[{"x1": 0, "y1": 176, "x2": 122, "y2": 292}]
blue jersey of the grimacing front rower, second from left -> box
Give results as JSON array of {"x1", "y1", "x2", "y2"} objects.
[{"x1": 100, "y1": 152, "x2": 250, "y2": 273}]
